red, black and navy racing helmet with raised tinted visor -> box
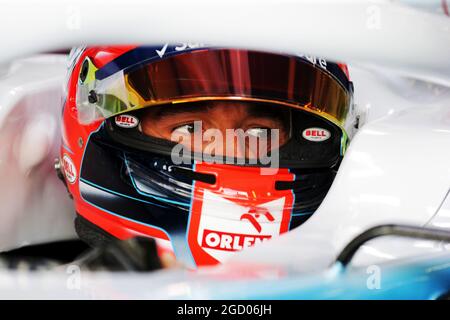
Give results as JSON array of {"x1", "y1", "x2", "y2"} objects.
[{"x1": 59, "y1": 44, "x2": 357, "y2": 267}]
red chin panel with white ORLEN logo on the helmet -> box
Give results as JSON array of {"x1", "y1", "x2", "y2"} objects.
[{"x1": 188, "y1": 164, "x2": 294, "y2": 265}]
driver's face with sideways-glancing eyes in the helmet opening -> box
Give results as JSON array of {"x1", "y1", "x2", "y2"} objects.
[{"x1": 140, "y1": 101, "x2": 290, "y2": 157}]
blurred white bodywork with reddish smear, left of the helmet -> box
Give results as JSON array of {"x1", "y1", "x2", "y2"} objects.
[{"x1": 0, "y1": 55, "x2": 75, "y2": 251}]
